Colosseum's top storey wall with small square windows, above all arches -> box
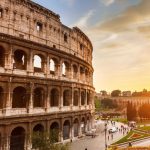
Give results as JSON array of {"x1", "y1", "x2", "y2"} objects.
[{"x1": 0, "y1": 0, "x2": 93, "y2": 63}]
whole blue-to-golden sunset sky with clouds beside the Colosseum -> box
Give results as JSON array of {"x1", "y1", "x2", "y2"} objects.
[{"x1": 33, "y1": 0, "x2": 150, "y2": 92}]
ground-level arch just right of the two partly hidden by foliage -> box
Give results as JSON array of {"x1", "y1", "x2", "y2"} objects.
[{"x1": 63, "y1": 120, "x2": 70, "y2": 140}]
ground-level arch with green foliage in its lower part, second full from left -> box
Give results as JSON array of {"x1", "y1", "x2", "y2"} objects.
[{"x1": 32, "y1": 124, "x2": 45, "y2": 149}]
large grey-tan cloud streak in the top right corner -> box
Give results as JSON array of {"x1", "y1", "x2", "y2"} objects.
[{"x1": 97, "y1": 0, "x2": 150, "y2": 32}]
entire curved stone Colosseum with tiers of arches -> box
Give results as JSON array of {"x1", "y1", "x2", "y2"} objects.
[{"x1": 0, "y1": 0, "x2": 94, "y2": 150}]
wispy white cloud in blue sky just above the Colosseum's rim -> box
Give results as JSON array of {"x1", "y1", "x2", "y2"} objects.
[{"x1": 71, "y1": 10, "x2": 94, "y2": 29}]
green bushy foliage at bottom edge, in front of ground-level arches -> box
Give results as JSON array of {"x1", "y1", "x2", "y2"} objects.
[{"x1": 32, "y1": 130, "x2": 69, "y2": 150}]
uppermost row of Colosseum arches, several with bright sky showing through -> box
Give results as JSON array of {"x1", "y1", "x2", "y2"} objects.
[{"x1": 0, "y1": 45, "x2": 93, "y2": 85}]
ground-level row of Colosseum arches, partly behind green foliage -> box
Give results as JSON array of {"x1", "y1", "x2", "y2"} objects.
[{"x1": 0, "y1": 114, "x2": 92, "y2": 150}]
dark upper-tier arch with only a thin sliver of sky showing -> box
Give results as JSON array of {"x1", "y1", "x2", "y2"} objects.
[{"x1": 13, "y1": 50, "x2": 27, "y2": 70}]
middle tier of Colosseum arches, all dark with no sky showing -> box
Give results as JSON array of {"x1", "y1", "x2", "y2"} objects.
[{"x1": 0, "y1": 82, "x2": 94, "y2": 115}]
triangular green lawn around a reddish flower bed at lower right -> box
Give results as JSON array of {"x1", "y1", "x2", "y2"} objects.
[{"x1": 112, "y1": 131, "x2": 150, "y2": 145}]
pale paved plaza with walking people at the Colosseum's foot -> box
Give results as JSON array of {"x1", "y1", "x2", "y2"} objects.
[{"x1": 71, "y1": 122, "x2": 128, "y2": 150}]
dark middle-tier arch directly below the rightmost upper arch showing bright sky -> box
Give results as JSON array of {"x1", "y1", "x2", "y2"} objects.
[{"x1": 63, "y1": 90, "x2": 71, "y2": 106}]
